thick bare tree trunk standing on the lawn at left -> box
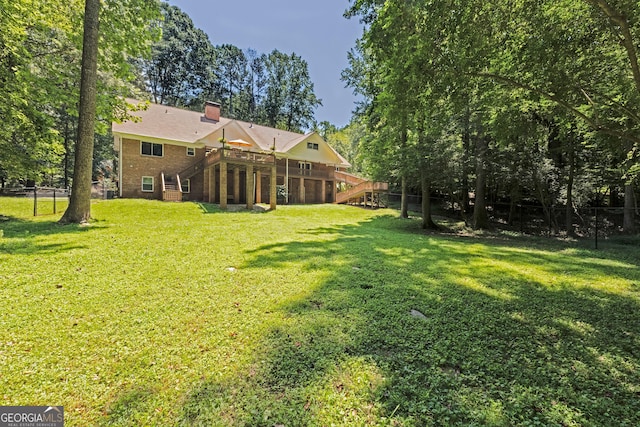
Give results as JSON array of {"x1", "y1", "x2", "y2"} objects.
[{"x1": 60, "y1": 0, "x2": 100, "y2": 224}]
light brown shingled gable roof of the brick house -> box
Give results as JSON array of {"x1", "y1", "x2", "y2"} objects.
[{"x1": 112, "y1": 99, "x2": 351, "y2": 167}]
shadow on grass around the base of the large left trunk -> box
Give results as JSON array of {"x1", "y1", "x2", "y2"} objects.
[{"x1": 0, "y1": 217, "x2": 102, "y2": 254}]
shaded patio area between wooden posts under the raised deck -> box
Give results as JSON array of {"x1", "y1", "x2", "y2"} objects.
[{"x1": 203, "y1": 148, "x2": 277, "y2": 210}]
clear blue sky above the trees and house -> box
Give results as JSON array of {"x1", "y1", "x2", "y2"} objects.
[{"x1": 169, "y1": 0, "x2": 362, "y2": 126}]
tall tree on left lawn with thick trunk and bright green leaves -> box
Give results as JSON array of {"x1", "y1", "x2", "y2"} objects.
[{"x1": 61, "y1": 0, "x2": 158, "y2": 223}]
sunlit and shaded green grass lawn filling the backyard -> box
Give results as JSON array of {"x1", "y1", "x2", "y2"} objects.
[{"x1": 0, "y1": 198, "x2": 640, "y2": 426}]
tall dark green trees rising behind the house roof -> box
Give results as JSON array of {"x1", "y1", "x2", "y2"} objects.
[{"x1": 136, "y1": 3, "x2": 320, "y2": 130}]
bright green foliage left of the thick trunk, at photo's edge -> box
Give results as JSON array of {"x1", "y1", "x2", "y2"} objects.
[{"x1": 0, "y1": 0, "x2": 77, "y2": 182}]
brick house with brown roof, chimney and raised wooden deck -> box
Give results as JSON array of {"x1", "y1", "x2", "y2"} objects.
[{"x1": 113, "y1": 100, "x2": 362, "y2": 209}]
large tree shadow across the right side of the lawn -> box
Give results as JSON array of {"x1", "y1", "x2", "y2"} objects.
[{"x1": 180, "y1": 217, "x2": 640, "y2": 426}]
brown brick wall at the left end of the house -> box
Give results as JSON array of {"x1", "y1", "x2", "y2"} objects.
[{"x1": 120, "y1": 138, "x2": 205, "y2": 200}]
